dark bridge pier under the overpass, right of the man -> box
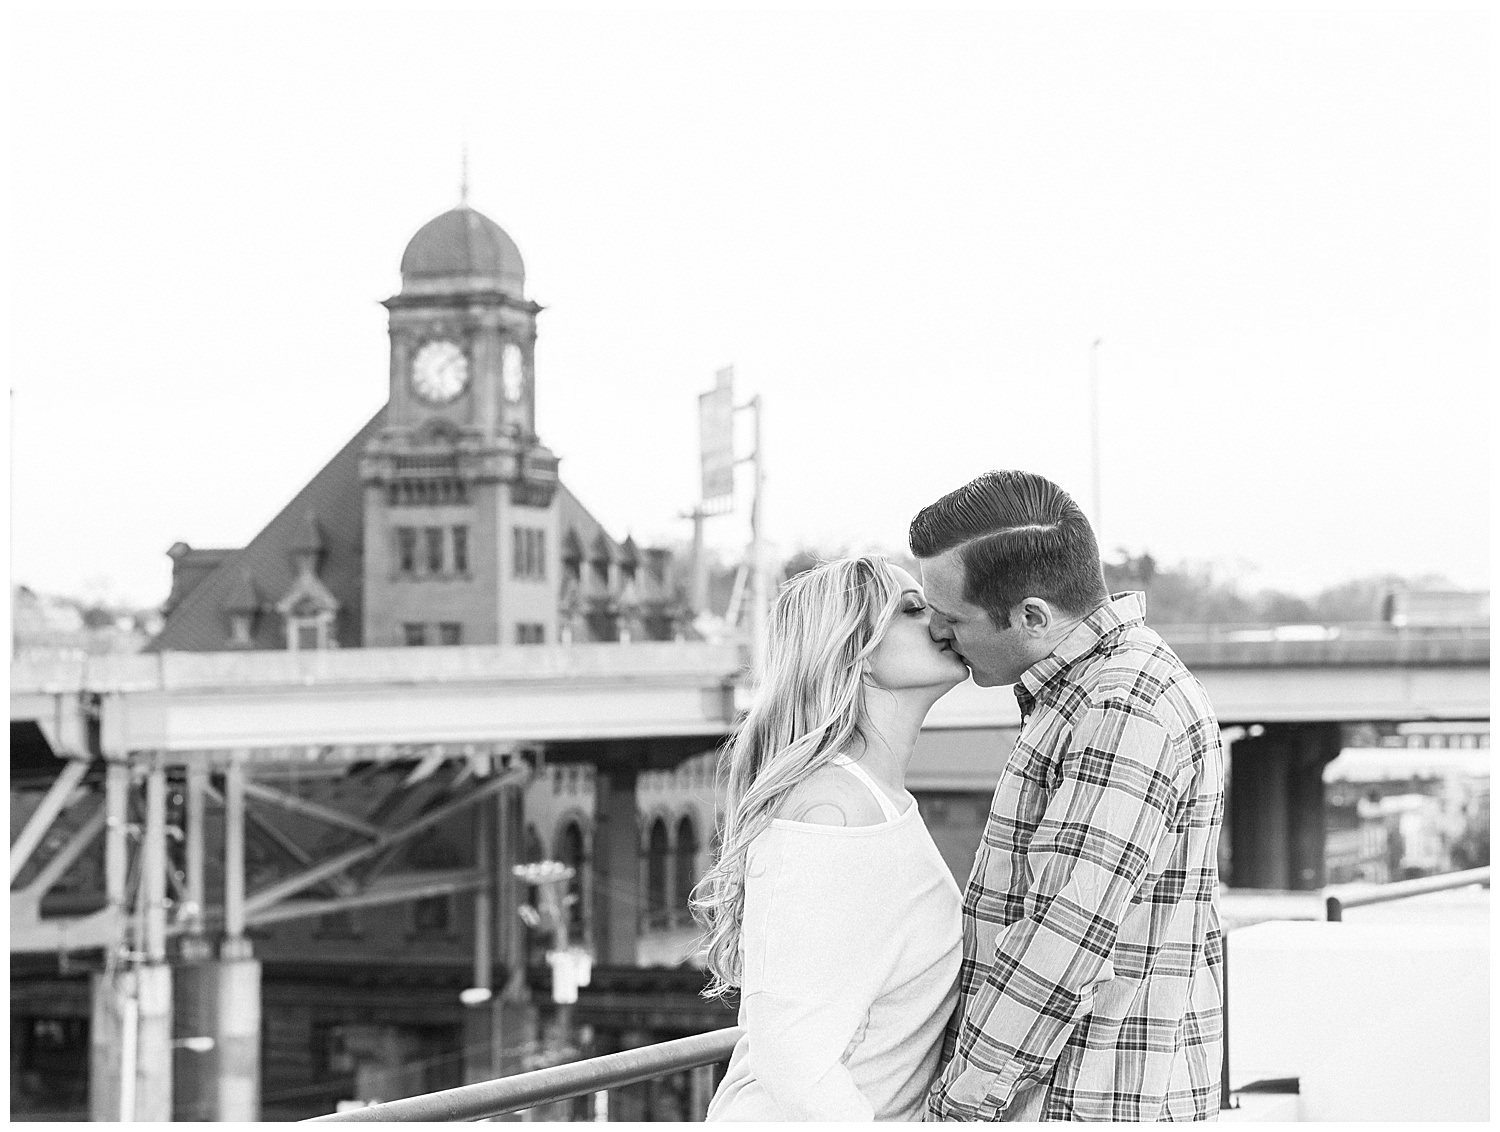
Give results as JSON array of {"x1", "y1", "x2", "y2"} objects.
[{"x1": 1226, "y1": 723, "x2": 1343, "y2": 891}]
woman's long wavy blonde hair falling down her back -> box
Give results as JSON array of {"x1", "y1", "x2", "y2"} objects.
[{"x1": 692, "y1": 555, "x2": 902, "y2": 997}]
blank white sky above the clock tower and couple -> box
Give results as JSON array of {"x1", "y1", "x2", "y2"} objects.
[{"x1": 9, "y1": 9, "x2": 1490, "y2": 603}]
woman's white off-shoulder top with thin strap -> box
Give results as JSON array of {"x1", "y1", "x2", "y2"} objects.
[{"x1": 708, "y1": 756, "x2": 963, "y2": 1120}]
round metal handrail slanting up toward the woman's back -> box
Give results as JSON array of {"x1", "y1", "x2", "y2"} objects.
[{"x1": 312, "y1": 1026, "x2": 744, "y2": 1120}]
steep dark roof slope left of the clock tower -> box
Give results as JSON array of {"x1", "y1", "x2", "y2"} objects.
[{"x1": 147, "y1": 408, "x2": 386, "y2": 652}]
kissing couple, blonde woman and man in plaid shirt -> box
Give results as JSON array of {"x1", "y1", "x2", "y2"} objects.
[{"x1": 695, "y1": 471, "x2": 1224, "y2": 1120}]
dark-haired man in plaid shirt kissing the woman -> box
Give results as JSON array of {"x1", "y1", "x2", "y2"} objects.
[{"x1": 911, "y1": 471, "x2": 1224, "y2": 1120}]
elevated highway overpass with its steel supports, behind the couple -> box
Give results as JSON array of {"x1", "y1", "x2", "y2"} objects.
[{"x1": 11, "y1": 627, "x2": 1490, "y2": 1113}]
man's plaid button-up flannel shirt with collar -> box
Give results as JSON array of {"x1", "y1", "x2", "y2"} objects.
[{"x1": 927, "y1": 594, "x2": 1224, "y2": 1120}]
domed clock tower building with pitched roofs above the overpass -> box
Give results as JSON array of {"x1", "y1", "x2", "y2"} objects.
[{"x1": 150, "y1": 205, "x2": 689, "y2": 651}]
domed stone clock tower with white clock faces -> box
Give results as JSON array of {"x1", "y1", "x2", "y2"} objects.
[{"x1": 360, "y1": 204, "x2": 560, "y2": 648}]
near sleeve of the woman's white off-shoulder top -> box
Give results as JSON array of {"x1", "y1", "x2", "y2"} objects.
[{"x1": 743, "y1": 835, "x2": 893, "y2": 1122}]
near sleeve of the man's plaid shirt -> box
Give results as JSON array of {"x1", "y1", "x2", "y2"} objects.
[{"x1": 929, "y1": 700, "x2": 1182, "y2": 1120}]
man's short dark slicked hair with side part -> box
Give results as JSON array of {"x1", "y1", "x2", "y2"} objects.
[{"x1": 911, "y1": 471, "x2": 1109, "y2": 628}]
